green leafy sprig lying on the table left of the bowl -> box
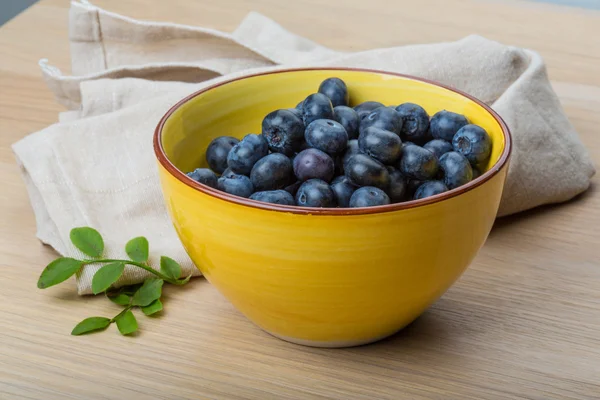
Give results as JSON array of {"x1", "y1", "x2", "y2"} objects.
[{"x1": 37, "y1": 227, "x2": 191, "y2": 335}]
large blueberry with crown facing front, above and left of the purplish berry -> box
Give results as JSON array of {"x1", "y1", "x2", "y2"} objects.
[{"x1": 262, "y1": 110, "x2": 304, "y2": 156}]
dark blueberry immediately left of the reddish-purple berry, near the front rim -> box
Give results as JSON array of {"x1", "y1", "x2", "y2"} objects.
[{"x1": 250, "y1": 153, "x2": 293, "y2": 192}]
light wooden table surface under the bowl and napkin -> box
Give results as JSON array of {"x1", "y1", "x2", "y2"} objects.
[{"x1": 0, "y1": 0, "x2": 600, "y2": 400}]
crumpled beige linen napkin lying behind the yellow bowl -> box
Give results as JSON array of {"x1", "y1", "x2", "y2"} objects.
[{"x1": 13, "y1": 2, "x2": 595, "y2": 294}]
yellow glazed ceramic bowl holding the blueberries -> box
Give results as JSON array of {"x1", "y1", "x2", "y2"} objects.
[{"x1": 154, "y1": 69, "x2": 511, "y2": 347}]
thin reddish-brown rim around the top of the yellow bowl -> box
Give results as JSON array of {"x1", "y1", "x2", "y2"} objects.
[{"x1": 153, "y1": 67, "x2": 512, "y2": 216}]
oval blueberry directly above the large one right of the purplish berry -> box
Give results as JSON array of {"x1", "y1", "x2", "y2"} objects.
[{"x1": 358, "y1": 128, "x2": 402, "y2": 164}]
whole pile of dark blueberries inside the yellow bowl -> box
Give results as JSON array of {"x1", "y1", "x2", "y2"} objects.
[{"x1": 187, "y1": 78, "x2": 492, "y2": 207}]
